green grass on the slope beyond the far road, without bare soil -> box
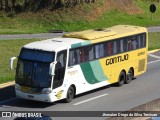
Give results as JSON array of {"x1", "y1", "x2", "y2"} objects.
[{"x1": 0, "y1": 0, "x2": 160, "y2": 34}]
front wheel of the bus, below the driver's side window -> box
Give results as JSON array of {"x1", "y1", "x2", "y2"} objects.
[{"x1": 65, "y1": 86, "x2": 75, "y2": 103}]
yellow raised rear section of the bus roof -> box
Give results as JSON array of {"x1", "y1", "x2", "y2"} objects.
[{"x1": 63, "y1": 25, "x2": 146, "y2": 40}]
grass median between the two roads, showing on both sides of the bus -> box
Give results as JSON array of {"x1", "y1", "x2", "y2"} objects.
[{"x1": 0, "y1": 32, "x2": 160, "y2": 83}]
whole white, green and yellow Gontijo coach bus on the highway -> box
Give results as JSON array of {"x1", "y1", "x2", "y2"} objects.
[{"x1": 10, "y1": 25, "x2": 148, "y2": 102}]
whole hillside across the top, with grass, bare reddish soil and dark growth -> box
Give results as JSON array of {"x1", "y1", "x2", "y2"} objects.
[{"x1": 0, "y1": 0, "x2": 160, "y2": 34}]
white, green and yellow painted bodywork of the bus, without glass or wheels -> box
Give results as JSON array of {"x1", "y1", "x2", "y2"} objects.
[{"x1": 11, "y1": 25, "x2": 148, "y2": 102}]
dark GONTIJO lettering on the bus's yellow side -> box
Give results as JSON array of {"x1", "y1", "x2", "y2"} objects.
[{"x1": 106, "y1": 54, "x2": 129, "y2": 65}]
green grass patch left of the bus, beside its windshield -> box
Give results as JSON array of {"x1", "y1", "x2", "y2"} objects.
[{"x1": 0, "y1": 39, "x2": 37, "y2": 83}]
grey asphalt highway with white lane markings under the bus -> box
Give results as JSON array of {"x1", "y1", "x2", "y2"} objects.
[{"x1": 0, "y1": 54, "x2": 160, "y2": 120}]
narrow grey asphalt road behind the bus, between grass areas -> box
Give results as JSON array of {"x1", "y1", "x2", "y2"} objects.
[{"x1": 0, "y1": 26, "x2": 160, "y2": 40}]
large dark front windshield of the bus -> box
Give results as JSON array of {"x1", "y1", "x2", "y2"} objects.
[{"x1": 16, "y1": 49, "x2": 55, "y2": 88}]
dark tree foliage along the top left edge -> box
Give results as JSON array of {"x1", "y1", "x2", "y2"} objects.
[{"x1": 0, "y1": 0, "x2": 96, "y2": 12}]
